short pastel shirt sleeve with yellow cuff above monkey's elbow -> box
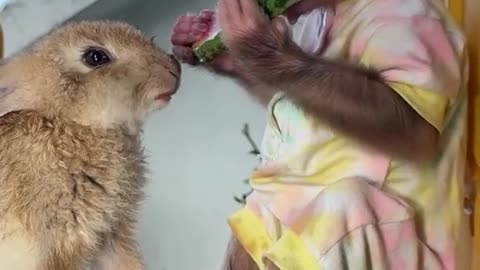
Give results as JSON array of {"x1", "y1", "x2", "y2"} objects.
[{"x1": 351, "y1": 15, "x2": 462, "y2": 132}]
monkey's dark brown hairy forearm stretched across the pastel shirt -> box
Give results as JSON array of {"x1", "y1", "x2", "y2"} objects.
[{"x1": 232, "y1": 33, "x2": 437, "y2": 158}]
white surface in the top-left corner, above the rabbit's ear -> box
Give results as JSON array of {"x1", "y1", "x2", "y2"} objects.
[{"x1": 0, "y1": 0, "x2": 97, "y2": 57}]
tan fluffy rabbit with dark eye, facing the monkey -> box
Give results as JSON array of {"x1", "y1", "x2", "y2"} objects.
[{"x1": 0, "y1": 21, "x2": 181, "y2": 270}]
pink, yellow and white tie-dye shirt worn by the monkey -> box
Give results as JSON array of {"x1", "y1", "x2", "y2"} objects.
[{"x1": 229, "y1": 0, "x2": 471, "y2": 270}]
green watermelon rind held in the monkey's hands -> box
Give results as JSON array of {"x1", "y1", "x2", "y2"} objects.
[{"x1": 193, "y1": 0, "x2": 300, "y2": 63}]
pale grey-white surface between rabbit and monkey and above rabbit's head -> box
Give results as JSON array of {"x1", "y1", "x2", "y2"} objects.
[{"x1": 70, "y1": 0, "x2": 265, "y2": 270}]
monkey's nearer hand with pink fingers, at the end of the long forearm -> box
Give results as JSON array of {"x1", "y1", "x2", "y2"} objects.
[{"x1": 217, "y1": 0, "x2": 299, "y2": 106}]
